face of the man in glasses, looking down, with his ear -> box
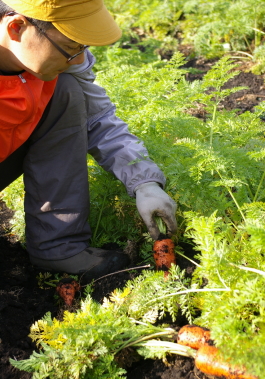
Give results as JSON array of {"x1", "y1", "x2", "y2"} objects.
[{"x1": 5, "y1": 15, "x2": 84, "y2": 81}]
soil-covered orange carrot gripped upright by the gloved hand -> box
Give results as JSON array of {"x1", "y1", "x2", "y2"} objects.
[{"x1": 153, "y1": 238, "x2": 176, "y2": 271}]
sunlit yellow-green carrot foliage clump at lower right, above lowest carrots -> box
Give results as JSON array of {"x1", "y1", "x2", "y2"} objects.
[{"x1": 183, "y1": 203, "x2": 265, "y2": 378}]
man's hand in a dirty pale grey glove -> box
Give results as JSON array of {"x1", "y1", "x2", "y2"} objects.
[{"x1": 135, "y1": 182, "x2": 177, "y2": 240}]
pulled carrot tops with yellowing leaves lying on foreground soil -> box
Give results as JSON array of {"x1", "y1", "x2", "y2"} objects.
[{"x1": 11, "y1": 266, "x2": 192, "y2": 379}]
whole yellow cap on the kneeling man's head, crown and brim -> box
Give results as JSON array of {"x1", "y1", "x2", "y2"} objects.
[{"x1": 4, "y1": 0, "x2": 121, "y2": 46}]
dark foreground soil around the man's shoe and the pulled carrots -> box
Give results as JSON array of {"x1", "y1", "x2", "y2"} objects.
[{"x1": 0, "y1": 203, "x2": 205, "y2": 379}]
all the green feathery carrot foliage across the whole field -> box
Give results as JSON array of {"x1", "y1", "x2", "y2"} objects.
[{"x1": 1, "y1": 6, "x2": 265, "y2": 378}]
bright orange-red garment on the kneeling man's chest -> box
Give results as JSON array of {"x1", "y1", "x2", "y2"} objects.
[{"x1": 0, "y1": 72, "x2": 57, "y2": 162}]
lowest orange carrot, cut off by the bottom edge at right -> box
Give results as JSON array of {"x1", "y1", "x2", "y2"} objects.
[{"x1": 195, "y1": 345, "x2": 258, "y2": 379}]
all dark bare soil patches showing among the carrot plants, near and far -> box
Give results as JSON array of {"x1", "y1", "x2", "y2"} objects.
[{"x1": 0, "y1": 59, "x2": 265, "y2": 379}]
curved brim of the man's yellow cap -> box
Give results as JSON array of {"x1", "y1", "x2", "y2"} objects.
[{"x1": 53, "y1": 5, "x2": 122, "y2": 46}]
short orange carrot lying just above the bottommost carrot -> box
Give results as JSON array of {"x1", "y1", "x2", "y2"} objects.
[{"x1": 177, "y1": 325, "x2": 211, "y2": 350}]
